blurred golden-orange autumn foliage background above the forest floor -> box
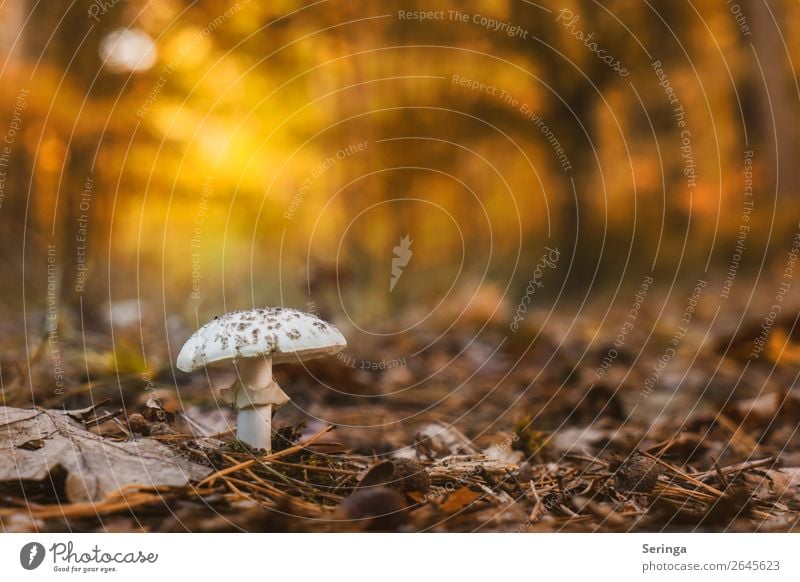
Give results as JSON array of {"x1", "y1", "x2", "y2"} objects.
[{"x1": 0, "y1": 0, "x2": 800, "y2": 323}]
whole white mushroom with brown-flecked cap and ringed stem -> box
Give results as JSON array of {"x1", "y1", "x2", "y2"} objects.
[{"x1": 177, "y1": 307, "x2": 347, "y2": 451}]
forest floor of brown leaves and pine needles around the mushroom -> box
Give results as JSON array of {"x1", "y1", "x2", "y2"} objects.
[{"x1": 0, "y1": 286, "x2": 800, "y2": 532}]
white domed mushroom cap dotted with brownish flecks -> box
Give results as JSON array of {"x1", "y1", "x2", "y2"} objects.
[{"x1": 178, "y1": 307, "x2": 347, "y2": 372}]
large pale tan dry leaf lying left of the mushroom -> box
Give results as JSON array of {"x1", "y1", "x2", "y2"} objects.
[{"x1": 0, "y1": 407, "x2": 211, "y2": 502}]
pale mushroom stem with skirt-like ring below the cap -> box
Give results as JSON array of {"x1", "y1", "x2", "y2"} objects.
[{"x1": 227, "y1": 358, "x2": 289, "y2": 452}]
